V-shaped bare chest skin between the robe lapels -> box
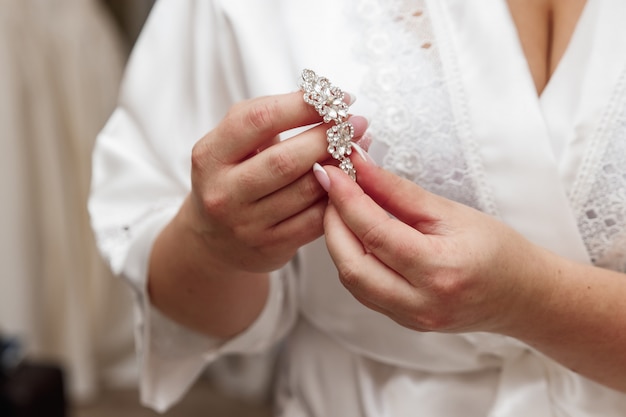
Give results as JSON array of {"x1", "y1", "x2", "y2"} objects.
[{"x1": 507, "y1": 0, "x2": 586, "y2": 95}]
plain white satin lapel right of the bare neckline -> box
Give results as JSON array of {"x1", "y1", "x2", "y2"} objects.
[{"x1": 541, "y1": 0, "x2": 626, "y2": 205}]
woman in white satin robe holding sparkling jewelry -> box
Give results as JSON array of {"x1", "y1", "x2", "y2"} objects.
[{"x1": 91, "y1": 0, "x2": 626, "y2": 416}]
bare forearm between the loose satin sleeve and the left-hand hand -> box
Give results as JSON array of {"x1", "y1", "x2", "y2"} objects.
[{"x1": 148, "y1": 198, "x2": 269, "y2": 338}]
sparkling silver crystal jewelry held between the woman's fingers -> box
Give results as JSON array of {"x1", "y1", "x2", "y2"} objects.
[{"x1": 300, "y1": 69, "x2": 356, "y2": 181}]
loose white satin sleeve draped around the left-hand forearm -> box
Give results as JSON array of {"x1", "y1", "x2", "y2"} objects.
[{"x1": 89, "y1": 0, "x2": 296, "y2": 411}]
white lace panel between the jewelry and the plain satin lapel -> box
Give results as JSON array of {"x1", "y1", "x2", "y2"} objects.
[{"x1": 356, "y1": 0, "x2": 482, "y2": 211}]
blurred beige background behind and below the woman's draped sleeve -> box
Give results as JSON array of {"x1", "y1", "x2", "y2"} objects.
[{"x1": 0, "y1": 0, "x2": 269, "y2": 417}]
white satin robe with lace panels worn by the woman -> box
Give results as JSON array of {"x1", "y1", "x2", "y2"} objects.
[{"x1": 90, "y1": 0, "x2": 626, "y2": 417}]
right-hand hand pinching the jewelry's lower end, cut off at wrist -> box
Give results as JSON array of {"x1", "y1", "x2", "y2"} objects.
[{"x1": 317, "y1": 155, "x2": 550, "y2": 334}]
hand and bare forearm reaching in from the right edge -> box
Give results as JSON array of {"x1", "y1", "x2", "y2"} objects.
[{"x1": 316, "y1": 155, "x2": 626, "y2": 393}]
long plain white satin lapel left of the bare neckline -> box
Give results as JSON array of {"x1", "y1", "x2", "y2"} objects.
[{"x1": 430, "y1": 0, "x2": 589, "y2": 263}]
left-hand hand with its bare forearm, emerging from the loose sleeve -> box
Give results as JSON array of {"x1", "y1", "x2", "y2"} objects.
[{"x1": 148, "y1": 92, "x2": 367, "y2": 338}]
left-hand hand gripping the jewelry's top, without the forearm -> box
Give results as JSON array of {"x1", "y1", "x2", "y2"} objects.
[{"x1": 180, "y1": 92, "x2": 367, "y2": 272}]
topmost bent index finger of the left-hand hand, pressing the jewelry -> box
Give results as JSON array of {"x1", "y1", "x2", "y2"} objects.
[{"x1": 207, "y1": 91, "x2": 322, "y2": 163}]
